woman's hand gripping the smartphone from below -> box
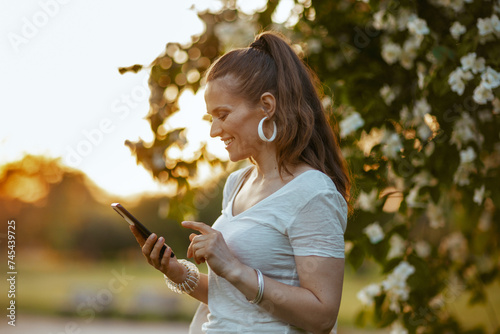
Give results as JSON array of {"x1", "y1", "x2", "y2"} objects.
[{"x1": 130, "y1": 225, "x2": 187, "y2": 283}]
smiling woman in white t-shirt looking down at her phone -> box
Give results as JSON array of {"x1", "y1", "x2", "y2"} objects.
[{"x1": 132, "y1": 32, "x2": 350, "y2": 333}]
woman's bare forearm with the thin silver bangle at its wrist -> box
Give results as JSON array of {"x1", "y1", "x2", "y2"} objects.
[{"x1": 226, "y1": 265, "x2": 338, "y2": 333}]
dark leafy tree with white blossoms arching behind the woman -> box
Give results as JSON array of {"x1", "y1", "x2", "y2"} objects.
[{"x1": 122, "y1": 0, "x2": 500, "y2": 333}]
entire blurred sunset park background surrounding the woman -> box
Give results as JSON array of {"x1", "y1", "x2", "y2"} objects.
[{"x1": 0, "y1": 0, "x2": 500, "y2": 333}]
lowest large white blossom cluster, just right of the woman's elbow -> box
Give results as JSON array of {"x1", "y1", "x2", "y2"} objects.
[{"x1": 357, "y1": 261, "x2": 415, "y2": 313}]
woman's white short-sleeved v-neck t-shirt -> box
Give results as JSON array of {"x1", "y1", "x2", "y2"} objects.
[{"x1": 197, "y1": 166, "x2": 347, "y2": 334}]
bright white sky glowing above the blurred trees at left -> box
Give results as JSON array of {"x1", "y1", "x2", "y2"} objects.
[{"x1": 0, "y1": 0, "x2": 230, "y2": 196}]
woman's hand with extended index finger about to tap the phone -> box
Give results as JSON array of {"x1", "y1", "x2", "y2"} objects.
[{"x1": 182, "y1": 221, "x2": 241, "y2": 278}]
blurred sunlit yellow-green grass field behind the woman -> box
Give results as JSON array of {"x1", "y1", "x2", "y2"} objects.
[{"x1": 1, "y1": 261, "x2": 500, "y2": 333}]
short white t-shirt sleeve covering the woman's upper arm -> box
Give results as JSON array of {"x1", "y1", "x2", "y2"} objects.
[{"x1": 288, "y1": 191, "x2": 347, "y2": 258}]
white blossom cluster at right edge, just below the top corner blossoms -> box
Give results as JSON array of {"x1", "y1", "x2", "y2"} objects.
[{"x1": 448, "y1": 52, "x2": 500, "y2": 104}]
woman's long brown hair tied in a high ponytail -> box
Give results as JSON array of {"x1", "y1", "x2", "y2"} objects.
[{"x1": 206, "y1": 32, "x2": 351, "y2": 203}]
